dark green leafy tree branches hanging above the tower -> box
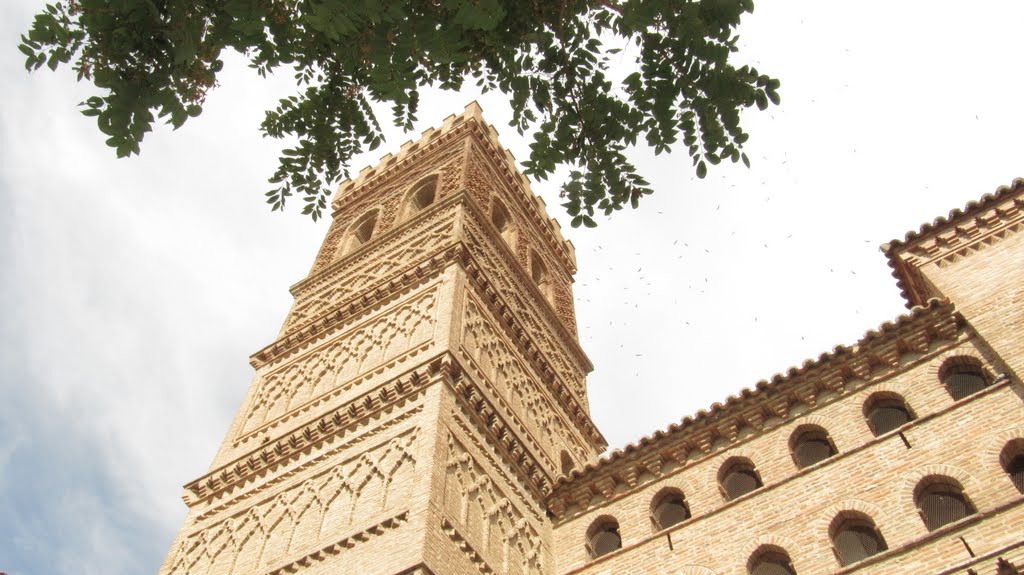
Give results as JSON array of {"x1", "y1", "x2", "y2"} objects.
[{"x1": 18, "y1": 0, "x2": 779, "y2": 226}]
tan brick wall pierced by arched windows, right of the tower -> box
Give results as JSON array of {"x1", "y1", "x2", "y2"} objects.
[{"x1": 554, "y1": 334, "x2": 1024, "y2": 575}]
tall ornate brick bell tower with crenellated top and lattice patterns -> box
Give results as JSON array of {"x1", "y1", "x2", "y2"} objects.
[{"x1": 161, "y1": 102, "x2": 605, "y2": 575}]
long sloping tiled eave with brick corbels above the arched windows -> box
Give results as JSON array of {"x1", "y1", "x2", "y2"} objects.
[{"x1": 548, "y1": 300, "x2": 964, "y2": 519}]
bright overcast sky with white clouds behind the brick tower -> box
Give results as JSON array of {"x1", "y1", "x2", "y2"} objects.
[{"x1": 0, "y1": 0, "x2": 1024, "y2": 575}]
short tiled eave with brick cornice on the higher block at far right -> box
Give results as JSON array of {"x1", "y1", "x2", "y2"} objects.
[{"x1": 882, "y1": 178, "x2": 1024, "y2": 307}]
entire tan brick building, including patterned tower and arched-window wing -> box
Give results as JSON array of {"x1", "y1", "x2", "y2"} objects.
[{"x1": 161, "y1": 103, "x2": 1024, "y2": 575}]
